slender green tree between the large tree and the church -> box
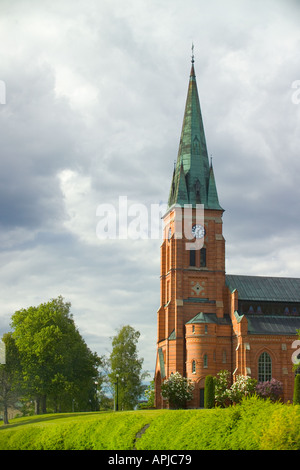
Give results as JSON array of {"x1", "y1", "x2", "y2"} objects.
[{"x1": 108, "y1": 325, "x2": 149, "y2": 410}]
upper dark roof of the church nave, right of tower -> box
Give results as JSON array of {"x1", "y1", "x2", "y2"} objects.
[{"x1": 226, "y1": 274, "x2": 300, "y2": 302}]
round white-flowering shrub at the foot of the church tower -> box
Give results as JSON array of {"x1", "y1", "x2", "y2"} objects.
[{"x1": 161, "y1": 372, "x2": 194, "y2": 408}]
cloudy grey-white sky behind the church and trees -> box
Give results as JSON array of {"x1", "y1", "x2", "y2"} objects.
[{"x1": 0, "y1": 0, "x2": 300, "y2": 376}]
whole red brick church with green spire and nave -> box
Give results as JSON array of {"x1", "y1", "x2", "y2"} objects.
[{"x1": 155, "y1": 55, "x2": 300, "y2": 408}]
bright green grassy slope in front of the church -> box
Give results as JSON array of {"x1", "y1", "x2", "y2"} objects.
[{"x1": 0, "y1": 398, "x2": 300, "y2": 450}]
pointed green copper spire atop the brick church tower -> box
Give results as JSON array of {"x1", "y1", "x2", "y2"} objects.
[{"x1": 168, "y1": 64, "x2": 223, "y2": 210}]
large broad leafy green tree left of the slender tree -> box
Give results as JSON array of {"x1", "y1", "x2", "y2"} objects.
[{"x1": 11, "y1": 296, "x2": 101, "y2": 414}]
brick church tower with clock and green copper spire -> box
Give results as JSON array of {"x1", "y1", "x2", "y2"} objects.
[{"x1": 155, "y1": 57, "x2": 231, "y2": 408}]
